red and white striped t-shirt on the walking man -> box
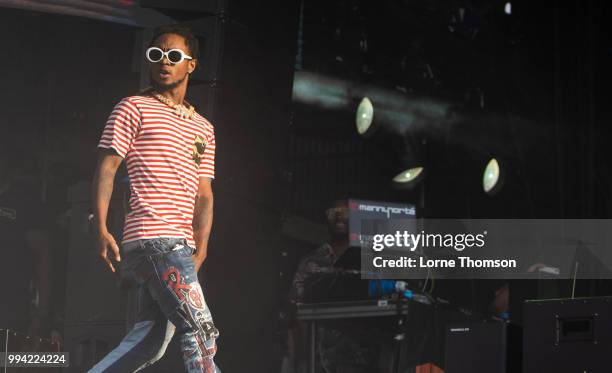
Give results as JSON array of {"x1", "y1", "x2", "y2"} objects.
[{"x1": 98, "y1": 96, "x2": 215, "y2": 245}]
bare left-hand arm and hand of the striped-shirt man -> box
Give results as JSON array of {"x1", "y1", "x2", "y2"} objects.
[{"x1": 92, "y1": 150, "x2": 123, "y2": 272}]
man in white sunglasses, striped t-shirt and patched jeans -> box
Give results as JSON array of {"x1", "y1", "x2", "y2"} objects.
[{"x1": 90, "y1": 26, "x2": 219, "y2": 373}]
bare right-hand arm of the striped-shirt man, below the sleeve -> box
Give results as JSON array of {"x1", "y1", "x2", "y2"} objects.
[{"x1": 193, "y1": 177, "x2": 213, "y2": 272}]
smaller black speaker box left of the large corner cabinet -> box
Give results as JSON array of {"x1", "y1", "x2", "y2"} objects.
[{"x1": 444, "y1": 322, "x2": 522, "y2": 373}]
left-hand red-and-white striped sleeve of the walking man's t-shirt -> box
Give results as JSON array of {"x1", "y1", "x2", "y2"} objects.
[{"x1": 98, "y1": 98, "x2": 141, "y2": 158}]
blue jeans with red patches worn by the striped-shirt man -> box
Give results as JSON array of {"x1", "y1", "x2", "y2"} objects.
[{"x1": 89, "y1": 238, "x2": 220, "y2": 373}]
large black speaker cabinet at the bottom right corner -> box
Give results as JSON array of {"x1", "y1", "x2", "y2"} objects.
[{"x1": 523, "y1": 297, "x2": 612, "y2": 373}]
